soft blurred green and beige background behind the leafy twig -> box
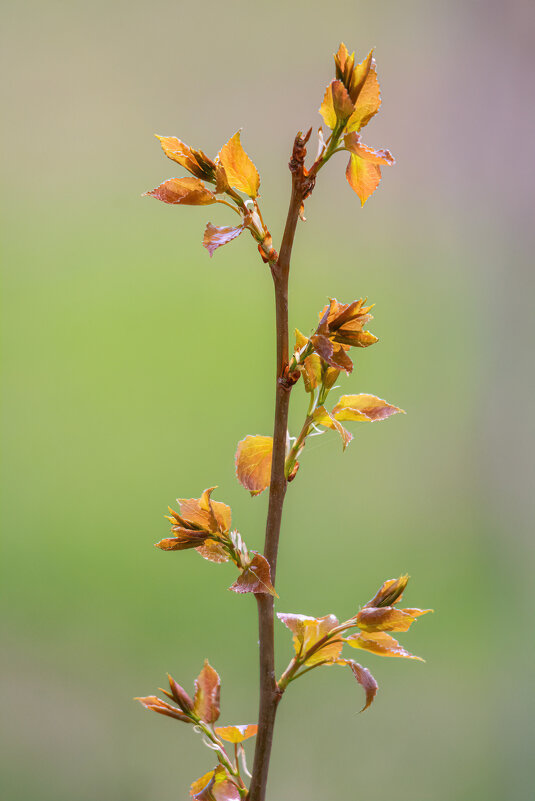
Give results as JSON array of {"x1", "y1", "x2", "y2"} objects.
[{"x1": 0, "y1": 0, "x2": 535, "y2": 801}]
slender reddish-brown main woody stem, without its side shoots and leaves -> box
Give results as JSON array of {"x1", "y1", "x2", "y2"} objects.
[{"x1": 249, "y1": 131, "x2": 310, "y2": 801}]
